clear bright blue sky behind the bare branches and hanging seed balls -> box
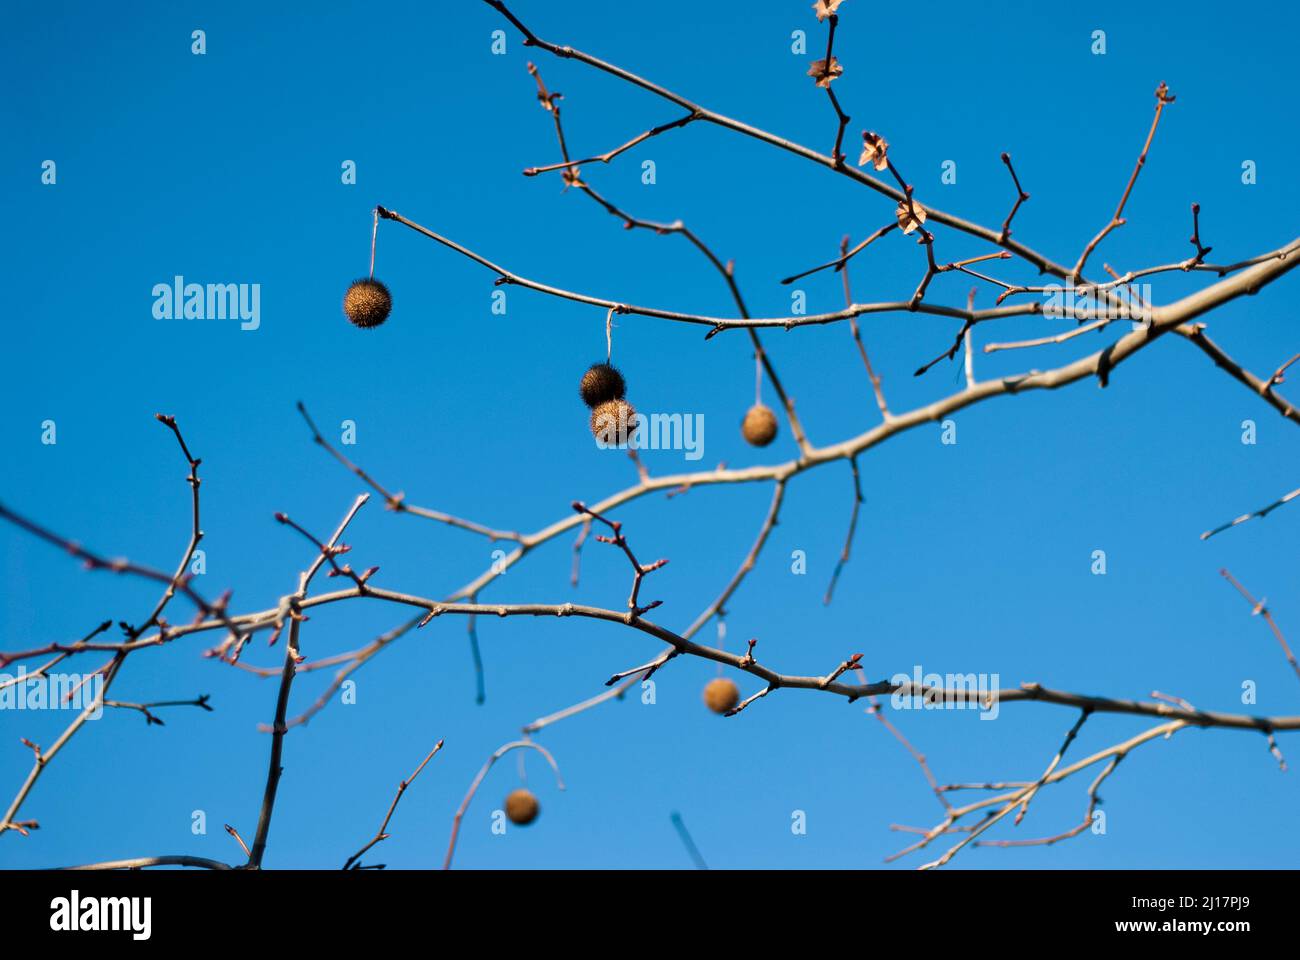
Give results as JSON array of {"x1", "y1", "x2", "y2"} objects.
[{"x1": 0, "y1": 0, "x2": 1300, "y2": 868}]
